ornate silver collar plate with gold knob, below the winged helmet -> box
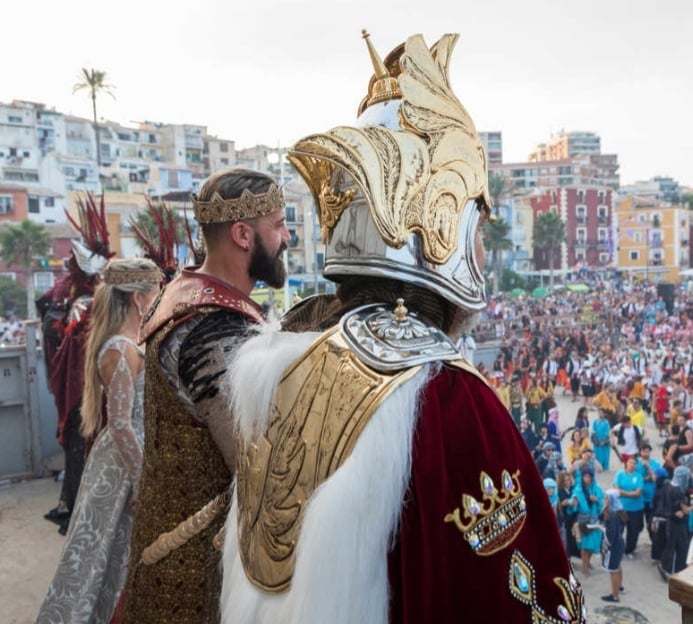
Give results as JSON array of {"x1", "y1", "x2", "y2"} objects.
[{"x1": 340, "y1": 299, "x2": 460, "y2": 371}]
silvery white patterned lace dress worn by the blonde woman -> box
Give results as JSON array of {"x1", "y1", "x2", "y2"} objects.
[{"x1": 36, "y1": 336, "x2": 144, "y2": 624}]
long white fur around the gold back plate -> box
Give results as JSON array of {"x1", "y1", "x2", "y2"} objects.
[{"x1": 221, "y1": 330, "x2": 429, "y2": 624}]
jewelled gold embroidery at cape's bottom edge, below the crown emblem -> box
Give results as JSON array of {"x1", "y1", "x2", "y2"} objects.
[{"x1": 508, "y1": 550, "x2": 586, "y2": 624}]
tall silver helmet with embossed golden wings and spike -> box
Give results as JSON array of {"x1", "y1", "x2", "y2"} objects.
[{"x1": 289, "y1": 31, "x2": 491, "y2": 311}]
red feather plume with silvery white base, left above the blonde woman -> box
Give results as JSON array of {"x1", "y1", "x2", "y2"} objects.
[{"x1": 65, "y1": 193, "x2": 115, "y2": 275}]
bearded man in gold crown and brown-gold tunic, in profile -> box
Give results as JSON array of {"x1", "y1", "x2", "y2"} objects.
[{"x1": 123, "y1": 169, "x2": 289, "y2": 624}]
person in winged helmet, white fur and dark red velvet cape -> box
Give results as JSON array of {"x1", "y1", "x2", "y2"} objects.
[{"x1": 222, "y1": 34, "x2": 585, "y2": 624}]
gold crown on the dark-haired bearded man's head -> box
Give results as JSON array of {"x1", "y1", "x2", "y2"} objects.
[{"x1": 193, "y1": 184, "x2": 284, "y2": 223}]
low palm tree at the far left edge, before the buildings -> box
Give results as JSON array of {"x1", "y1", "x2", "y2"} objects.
[{"x1": 0, "y1": 219, "x2": 53, "y2": 319}]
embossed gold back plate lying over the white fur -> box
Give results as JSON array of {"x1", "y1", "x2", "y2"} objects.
[{"x1": 236, "y1": 327, "x2": 420, "y2": 591}]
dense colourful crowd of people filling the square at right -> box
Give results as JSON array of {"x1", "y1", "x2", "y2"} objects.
[{"x1": 478, "y1": 280, "x2": 693, "y2": 602}]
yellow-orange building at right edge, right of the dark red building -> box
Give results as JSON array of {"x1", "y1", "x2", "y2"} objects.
[{"x1": 616, "y1": 195, "x2": 690, "y2": 282}]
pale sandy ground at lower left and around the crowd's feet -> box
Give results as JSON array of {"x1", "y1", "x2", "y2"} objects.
[{"x1": 0, "y1": 391, "x2": 681, "y2": 624}]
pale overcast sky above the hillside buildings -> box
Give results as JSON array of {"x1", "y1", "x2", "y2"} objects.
[{"x1": 5, "y1": 0, "x2": 693, "y2": 186}]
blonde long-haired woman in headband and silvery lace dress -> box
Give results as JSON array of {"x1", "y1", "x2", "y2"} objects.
[{"x1": 36, "y1": 259, "x2": 162, "y2": 624}]
